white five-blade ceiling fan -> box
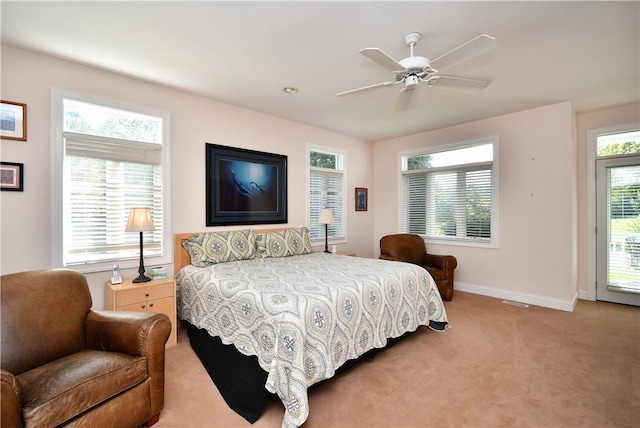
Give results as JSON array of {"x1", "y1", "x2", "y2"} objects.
[{"x1": 336, "y1": 32, "x2": 496, "y2": 110}]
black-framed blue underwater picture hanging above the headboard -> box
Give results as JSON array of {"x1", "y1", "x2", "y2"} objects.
[{"x1": 205, "y1": 143, "x2": 287, "y2": 226}]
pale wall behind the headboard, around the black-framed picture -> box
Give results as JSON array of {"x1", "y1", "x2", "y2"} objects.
[{"x1": 0, "y1": 46, "x2": 374, "y2": 309}]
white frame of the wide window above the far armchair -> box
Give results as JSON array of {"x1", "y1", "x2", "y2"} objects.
[{"x1": 398, "y1": 135, "x2": 500, "y2": 249}]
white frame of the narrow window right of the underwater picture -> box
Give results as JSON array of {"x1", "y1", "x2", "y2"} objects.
[{"x1": 305, "y1": 143, "x2": 348, "y2": 246}]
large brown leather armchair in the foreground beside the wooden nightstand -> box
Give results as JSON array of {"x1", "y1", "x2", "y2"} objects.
[{"x1": 0, "y1": 269, "x2": 171, "y2": 428}]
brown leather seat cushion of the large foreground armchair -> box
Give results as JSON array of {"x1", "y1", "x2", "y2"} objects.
[{"x1": 18, "y1": 350, "x2": 147, "y2": 426}]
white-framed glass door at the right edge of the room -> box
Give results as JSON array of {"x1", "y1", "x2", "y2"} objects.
[{"x1": 596, "y1": 154, "x2": 640, "y2": 306}]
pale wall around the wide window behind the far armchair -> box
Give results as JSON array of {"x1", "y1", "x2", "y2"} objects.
[{"x1": 374, "y1": 102, "x2": 577, "y2": 310}]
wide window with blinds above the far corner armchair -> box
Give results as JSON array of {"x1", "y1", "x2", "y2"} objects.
[{"x1": 400, "y1": 137, "x2": 497, "y2": 245}]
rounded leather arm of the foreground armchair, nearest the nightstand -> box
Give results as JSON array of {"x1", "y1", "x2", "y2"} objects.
[{"x1": 85, "y1": 311, "x2": 171, "y2": 357}]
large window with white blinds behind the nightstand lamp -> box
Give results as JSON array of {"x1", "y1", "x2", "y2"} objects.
[{"x1": 53, "y1": 91, "x2": 170, "y2": 272}]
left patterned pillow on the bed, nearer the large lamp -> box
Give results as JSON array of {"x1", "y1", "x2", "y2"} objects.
[{"x1": 182, "y1": 229, "x2": 256, "y2": 267}]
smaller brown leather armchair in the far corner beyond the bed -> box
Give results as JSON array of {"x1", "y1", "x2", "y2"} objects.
[{"x1": 380, "y1": 233, "x2": 458, "y2": 300}]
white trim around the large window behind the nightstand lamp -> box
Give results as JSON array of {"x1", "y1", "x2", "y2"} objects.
[{"x1": 51, "y1": 88, "x2": 173, "y2": 273}]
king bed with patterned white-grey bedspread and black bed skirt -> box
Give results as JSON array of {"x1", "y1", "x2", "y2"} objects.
[{"x1": 174, "y1": 227, "x2": 448, "y2": 428}]
